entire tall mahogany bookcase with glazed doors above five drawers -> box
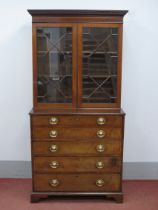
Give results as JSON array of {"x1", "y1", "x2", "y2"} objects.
[{"x1": 28, "y1": 10, "x2": 127, "y2": 202}]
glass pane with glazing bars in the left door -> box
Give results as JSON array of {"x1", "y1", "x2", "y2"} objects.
[{"x1": 37, "y1": 28, "x2": 72, "y2": 103}]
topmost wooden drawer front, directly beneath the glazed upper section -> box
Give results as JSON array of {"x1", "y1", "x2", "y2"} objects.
[{"x1": 32, "y1": 115, "x2": 122, "y2": 127}]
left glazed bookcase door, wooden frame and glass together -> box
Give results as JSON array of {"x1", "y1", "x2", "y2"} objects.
[{"x1": 33, "y1": 23, "x2": 77, "y2": 109}]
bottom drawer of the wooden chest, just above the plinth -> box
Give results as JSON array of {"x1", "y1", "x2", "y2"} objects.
[{"x1": 34, "y1": 174, "x2": 120, "y2": 192}]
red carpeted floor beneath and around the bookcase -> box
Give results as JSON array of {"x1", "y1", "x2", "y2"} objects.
[{"x1": 0, "y1": 179, "x2": 158, "y2": 210}]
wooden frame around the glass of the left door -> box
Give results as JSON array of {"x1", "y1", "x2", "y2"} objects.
[{"x1": 32, "y1": 23, "x2": 77, "y2": 110}]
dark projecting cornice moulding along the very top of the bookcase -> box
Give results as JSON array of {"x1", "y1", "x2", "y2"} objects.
[{"x1": 28, "y1": 9, "x2": 128, "y2": 17}]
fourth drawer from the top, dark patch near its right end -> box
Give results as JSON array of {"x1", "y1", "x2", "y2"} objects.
[{"x1": 33, "y1": 157, "x2": 121, "y2": 173}]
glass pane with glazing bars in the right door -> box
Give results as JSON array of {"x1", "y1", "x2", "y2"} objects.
[{"x1": 82, "y1": 28, "x2": 118, "y2": 103}]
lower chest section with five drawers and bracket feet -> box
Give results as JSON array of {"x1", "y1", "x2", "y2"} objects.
[{"x1": 31, "y1": 110, "x2": 124, "y2": 202}]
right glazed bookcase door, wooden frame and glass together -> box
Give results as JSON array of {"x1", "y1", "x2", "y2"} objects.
[{"x1": 78, "y1": 24, "x2": 122, "y2": 108}]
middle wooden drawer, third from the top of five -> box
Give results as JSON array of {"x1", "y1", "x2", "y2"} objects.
[{"x1": 32, "y1": 140, "x2": 122, "y2": 156}]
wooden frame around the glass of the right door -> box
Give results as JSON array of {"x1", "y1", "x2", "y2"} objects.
[{"x1": 77, "y1": 23, "x2": 122, "y2": 108}]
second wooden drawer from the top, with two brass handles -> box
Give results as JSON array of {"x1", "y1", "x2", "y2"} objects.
[{"x1": 32, "y1": 127, "x2": 122, "y2": 141}]
